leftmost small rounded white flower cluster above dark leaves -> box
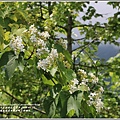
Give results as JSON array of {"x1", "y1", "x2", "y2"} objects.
[{"x1": 10, "y1": 36, "x2": 24, "y2": 54}]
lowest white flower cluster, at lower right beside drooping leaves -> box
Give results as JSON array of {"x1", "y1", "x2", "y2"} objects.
[{"x1": 88, "y1": 87, "x2": 104, "y2": 112}]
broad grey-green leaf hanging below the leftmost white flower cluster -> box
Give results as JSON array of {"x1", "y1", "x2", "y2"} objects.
[{"x1": 5, "y1": 56, "x2": 18, "y2": 79}]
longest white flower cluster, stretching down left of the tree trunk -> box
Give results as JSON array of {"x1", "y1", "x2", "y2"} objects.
[{"x1": 29, "y1": 25, "x2": 58, "y2": 70}]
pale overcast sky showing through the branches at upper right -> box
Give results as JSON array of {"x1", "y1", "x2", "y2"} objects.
[{"x1": 73, "y1": 1, "x2": 117, "y2": 38}]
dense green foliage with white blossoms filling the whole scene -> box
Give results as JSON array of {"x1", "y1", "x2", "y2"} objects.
[{"x1": 0, "y1": 2, "x2": 120, "y2": 118}]
